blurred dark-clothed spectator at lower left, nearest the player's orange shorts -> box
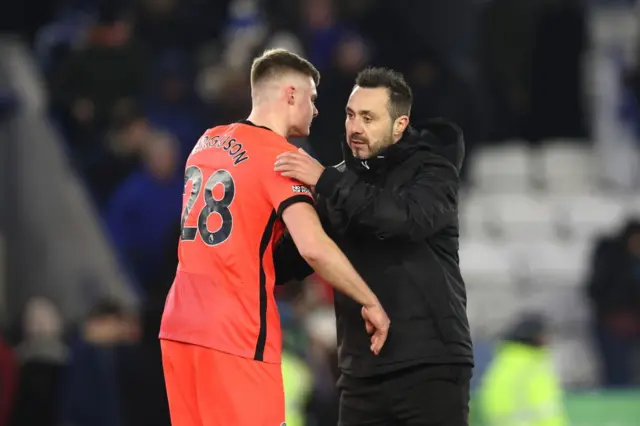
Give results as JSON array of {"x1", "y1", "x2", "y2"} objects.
[{"x1": 57, "y1": 300, "x2": 170, "y2": 426}]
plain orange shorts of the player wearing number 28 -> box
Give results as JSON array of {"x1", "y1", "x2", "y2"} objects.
[{"x1": 160, "y1": 340, "x2": 285, "y2": 426}]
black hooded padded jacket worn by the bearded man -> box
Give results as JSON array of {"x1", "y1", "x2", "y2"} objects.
[{"x1": 276, "y1": 120, "x2": 473, "y2": 376}]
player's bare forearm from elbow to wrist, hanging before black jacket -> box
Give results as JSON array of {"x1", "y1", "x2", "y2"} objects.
[{"x1": 305, "y1": 237, "x2": 378, "y2": 306}]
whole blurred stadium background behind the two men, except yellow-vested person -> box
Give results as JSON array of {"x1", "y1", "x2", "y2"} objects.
[{"x1": 0, "y1": 0, "x2": 640, "y2": 426}]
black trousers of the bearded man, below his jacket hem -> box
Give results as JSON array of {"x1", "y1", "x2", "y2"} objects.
[{"x1": 338, "y1": 365, "x2": 472, "y2": 426}]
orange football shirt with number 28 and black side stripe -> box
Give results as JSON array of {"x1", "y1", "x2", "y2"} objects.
[{"x1": 159, "y1": 121, "x2": 313, "y2": 363}]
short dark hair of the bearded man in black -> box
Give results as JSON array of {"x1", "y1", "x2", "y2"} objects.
[{"x1": 356, "y1": 67, "x2": 413, "y2": 120}]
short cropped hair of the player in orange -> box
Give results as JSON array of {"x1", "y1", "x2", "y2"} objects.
[{"x1": 251, "y1": 49, "x2": 320, "y2": 86}]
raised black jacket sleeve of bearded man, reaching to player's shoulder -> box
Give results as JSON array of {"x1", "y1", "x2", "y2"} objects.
[{"x1": 316, "y1": 159, "x2": 458, "y2": 241}]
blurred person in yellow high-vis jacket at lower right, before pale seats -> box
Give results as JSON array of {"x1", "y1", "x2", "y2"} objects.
[{"x1": 479, "y1": 315, "x2": 569, "y2": 426}]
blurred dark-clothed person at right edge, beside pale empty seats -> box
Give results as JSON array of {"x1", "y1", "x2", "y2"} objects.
[{"x1": 587, "y1": 220, "x2": 640, "y2": 387}]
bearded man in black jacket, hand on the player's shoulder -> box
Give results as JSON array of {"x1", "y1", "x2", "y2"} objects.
[{"x1": 275, "y1": 68, "x2": 473, "y2": 426}]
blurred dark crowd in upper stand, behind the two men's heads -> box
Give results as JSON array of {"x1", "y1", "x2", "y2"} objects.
[{"x1": 33, "y1": 0, "x2": 586, "y2": 294}]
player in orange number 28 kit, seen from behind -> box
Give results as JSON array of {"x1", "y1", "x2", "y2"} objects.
[{"x1": 160, "y1": 50, "x2": 389, "y2": 426}]
